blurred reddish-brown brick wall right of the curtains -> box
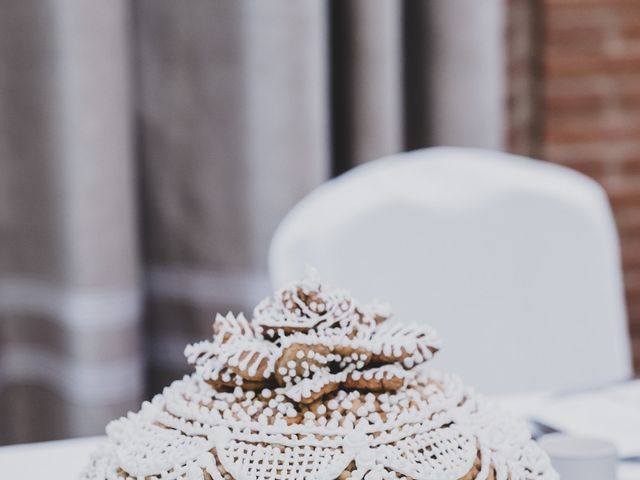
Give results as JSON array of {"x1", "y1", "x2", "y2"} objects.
[{"x1": 507, "y1": 0, "x2": 640, "y2": 372}]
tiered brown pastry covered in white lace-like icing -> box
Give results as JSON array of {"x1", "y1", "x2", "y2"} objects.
[{"x1": 81, "y1": 278, "x2": 558, "y2": 480}]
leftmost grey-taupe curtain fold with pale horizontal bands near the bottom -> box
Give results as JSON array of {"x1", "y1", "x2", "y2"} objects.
[{"x1": 0, "y1": 0, "x2": 143, "y2": 442}]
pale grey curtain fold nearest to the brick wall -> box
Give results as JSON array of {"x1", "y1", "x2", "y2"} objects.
[{"x1": 422, "y1": 0, "x2": 506, "y2": 150}]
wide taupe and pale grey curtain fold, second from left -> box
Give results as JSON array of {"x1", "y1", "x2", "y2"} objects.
[{"x1": 136, "y1": 0, "x2": 329, "y2": 390}]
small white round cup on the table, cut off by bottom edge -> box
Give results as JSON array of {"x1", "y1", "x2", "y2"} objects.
[{"x1": 538, "y1": 433, "x2": 618, "y2": 480}]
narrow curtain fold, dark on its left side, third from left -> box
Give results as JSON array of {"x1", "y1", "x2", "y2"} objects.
[{"x1": 329, "y1": 0, "x2": 404, "y2": 172}]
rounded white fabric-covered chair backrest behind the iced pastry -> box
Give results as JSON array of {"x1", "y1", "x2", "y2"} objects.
[{"x1": 269, "y1": 147, "x2": 631, "y2": 393}]
